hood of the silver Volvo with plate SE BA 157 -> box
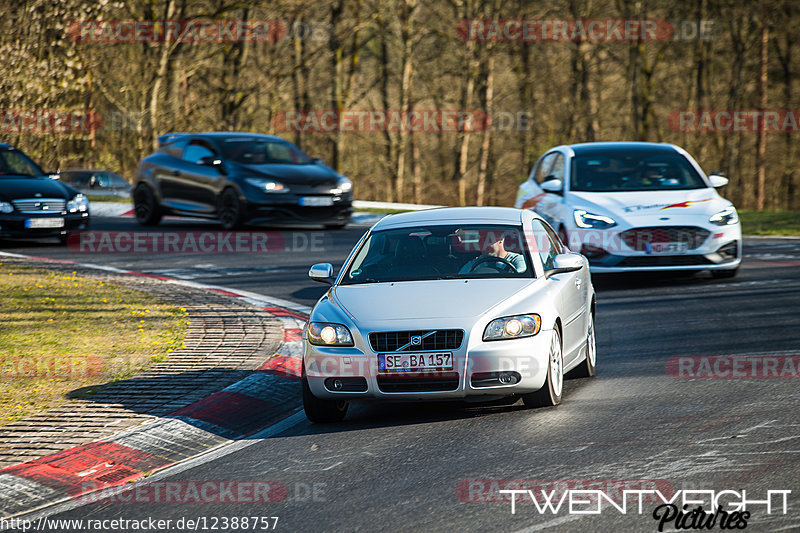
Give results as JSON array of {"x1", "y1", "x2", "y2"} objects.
[{"x1": 333, "y1": 278, "x2": 536, "y2": 323}]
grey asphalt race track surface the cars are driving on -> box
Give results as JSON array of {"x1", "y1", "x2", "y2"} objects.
[{"x1": 0, "y1": 218, "x2": 800, "y2": 532}]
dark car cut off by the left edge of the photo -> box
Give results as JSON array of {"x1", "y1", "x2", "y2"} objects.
[{"x1": 0, "y1": 143, "x2": 89, "y2": 242}]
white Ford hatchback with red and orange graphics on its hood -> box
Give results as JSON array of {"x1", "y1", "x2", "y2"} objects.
[{"x1": 515, "y1": 142, "x2": 742, "y2": 277}]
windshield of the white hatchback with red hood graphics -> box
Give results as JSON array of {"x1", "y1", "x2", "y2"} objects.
[{"x1": 570, "y1": 150, "x2": 707, "y2": 192}]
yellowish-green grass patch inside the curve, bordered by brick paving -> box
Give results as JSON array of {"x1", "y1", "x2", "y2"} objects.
[{"x1": 0, "y1": 263, "x2": 189, "y2": 425}]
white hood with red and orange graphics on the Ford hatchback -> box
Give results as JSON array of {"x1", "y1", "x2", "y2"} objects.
[{"x1": 569, "y1": 187, "x2": 730, "y2": 219}]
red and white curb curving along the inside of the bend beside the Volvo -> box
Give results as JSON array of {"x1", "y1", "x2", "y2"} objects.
[{"x1": 0, "y1": 252, "x2": 311, "y2": 519}]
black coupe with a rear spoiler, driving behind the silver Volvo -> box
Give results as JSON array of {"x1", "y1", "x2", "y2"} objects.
[{"x1": 133, "y1": 133, "x2": 353, "y2": 229}]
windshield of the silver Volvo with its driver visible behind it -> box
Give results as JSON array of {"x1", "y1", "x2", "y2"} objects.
[{"x1": 340, "y1": 225, "x2": 534, "y2": 285}]
